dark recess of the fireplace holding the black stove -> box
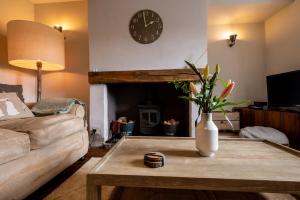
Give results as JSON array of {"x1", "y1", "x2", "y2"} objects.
[{"x1": 107, "y1": 83, "x2": 189, "y2": 137}]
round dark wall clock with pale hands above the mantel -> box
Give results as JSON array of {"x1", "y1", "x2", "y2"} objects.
[{"x1": 129, "y1": 10, "x2": 163, "y2": 44}]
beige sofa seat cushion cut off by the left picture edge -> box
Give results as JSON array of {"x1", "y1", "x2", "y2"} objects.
[{"x1": 0, "y1": 129, "x2": 30, "y2": 164}]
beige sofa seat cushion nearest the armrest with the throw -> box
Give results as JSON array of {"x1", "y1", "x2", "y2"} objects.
[{"x1": 0, "y1": 114, "x2": 85, "y2": 149}]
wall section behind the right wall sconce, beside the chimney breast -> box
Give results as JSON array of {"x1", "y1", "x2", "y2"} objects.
[{"x1": 208, "y1": 23, "x2": 267, "y2": 101}]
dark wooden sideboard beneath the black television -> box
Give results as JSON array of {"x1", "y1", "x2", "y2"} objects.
[{"x1": 234, "y1": 108, "x2": 300, "y2": 149}]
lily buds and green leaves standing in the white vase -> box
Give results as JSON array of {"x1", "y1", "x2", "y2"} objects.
[{"x1": 174, "y1": 61, "x2": 241, "y2": 125}]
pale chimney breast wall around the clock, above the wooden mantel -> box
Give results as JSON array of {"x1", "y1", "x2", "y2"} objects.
[{"x1": 89, "y1": 0, "x2": 207, "y2": 71}]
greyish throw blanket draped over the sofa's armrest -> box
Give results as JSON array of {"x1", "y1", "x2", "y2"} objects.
[{"x1": 31, "y1": 98, "x2": 86, "y2": 119}]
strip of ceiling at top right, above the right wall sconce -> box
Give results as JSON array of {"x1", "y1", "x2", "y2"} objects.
[{"x1": 208, "y1": 0, "x2": 294, "y2": 25}]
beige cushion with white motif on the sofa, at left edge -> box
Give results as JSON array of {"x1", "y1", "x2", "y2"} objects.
[{"x1": 0, "y1": 93, "x2": 33, "y2": 121}]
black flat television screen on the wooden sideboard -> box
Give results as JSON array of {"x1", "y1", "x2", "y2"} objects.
[{"x1": 267, "y1": 70, "x2": 300, "y2": 107}]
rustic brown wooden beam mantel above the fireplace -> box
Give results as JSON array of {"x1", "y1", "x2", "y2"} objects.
[{"x1": 89, "y1": 69, "x2": 201, "y2": 84}]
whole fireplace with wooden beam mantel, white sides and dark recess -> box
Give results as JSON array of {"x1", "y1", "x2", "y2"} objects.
[{"x1": 89, "y1": 69, "x2": 202, "y2": 141}]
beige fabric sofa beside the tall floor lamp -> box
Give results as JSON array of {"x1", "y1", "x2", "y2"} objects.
[{"x1": 0, "y1": 105, "x2": 89, "y2": 200}]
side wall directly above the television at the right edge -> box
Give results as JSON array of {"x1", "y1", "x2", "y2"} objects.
[{"x1": 266, "y1": 0, "x2": 300, "y2": 75}]
